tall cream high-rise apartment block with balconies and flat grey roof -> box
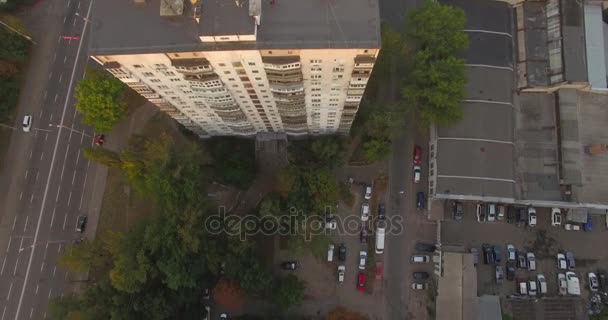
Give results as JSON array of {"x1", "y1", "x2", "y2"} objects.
[{"x1": 89, "y1": 0, "x2": 380, "y2": 137}]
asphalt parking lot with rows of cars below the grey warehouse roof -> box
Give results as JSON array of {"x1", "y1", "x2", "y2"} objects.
[{"x1": 441, "y1": 203, "x2": 608, "y2": 319}]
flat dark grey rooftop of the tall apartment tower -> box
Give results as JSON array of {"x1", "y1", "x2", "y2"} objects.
[{"x1": 89, "y1": 0, "x2": 380, "y2": 55}]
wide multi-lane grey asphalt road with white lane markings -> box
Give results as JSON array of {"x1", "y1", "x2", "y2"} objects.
[{"x1": 0, "y1": 0, "x2": 93, "y2": 320}]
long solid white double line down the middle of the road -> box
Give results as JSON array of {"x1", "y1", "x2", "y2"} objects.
[{"x1": 14, "y1": 0, "x2": 93, "y2": 320}]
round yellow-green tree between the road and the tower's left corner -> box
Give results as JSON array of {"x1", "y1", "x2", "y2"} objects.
[{"x1": 75, "y1": 69, "x2": 126, "y2": 132}]
